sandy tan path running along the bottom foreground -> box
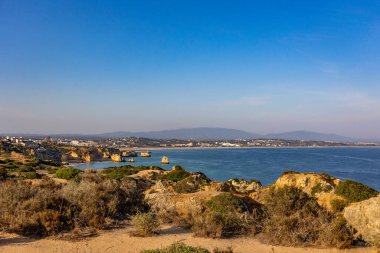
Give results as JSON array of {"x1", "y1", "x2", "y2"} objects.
[{"x1": 0, "y1": 228, "x2": 377, "y2": 253}]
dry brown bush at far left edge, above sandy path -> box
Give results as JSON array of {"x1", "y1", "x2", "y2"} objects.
[{"x1": 0, "y1": 181, "x2": 71, "y2": 236}]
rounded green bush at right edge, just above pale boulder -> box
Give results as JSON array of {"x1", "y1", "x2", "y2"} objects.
[{"x1": 335, "y1": 180, "x2": 378, "y2": 203}]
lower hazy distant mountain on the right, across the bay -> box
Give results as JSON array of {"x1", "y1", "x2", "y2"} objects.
[{"x1": 264, "y1": 131, "x2": 357, "y2": 142}]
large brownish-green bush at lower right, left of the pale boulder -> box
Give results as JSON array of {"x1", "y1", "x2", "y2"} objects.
[{"x1": 262, "y1": 186, "x2": 353, "y2": 248}]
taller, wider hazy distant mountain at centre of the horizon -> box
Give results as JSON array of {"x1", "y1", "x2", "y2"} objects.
[{"x1": 101, "y1": 127, "x2": 260, "y2": 140}]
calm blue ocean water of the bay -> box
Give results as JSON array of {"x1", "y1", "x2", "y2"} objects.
[{"x1": 72, "y1": 148, "x2": 380, "y2": 191}]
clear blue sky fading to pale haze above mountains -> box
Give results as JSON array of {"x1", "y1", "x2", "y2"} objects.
[{"x1": 0, "y1": 0, "x2": 380, "y2": 138}]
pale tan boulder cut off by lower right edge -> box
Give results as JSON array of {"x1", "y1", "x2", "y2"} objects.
[{"x1": 343, "y1": 195, "x2": 380, "y2": 243}]
